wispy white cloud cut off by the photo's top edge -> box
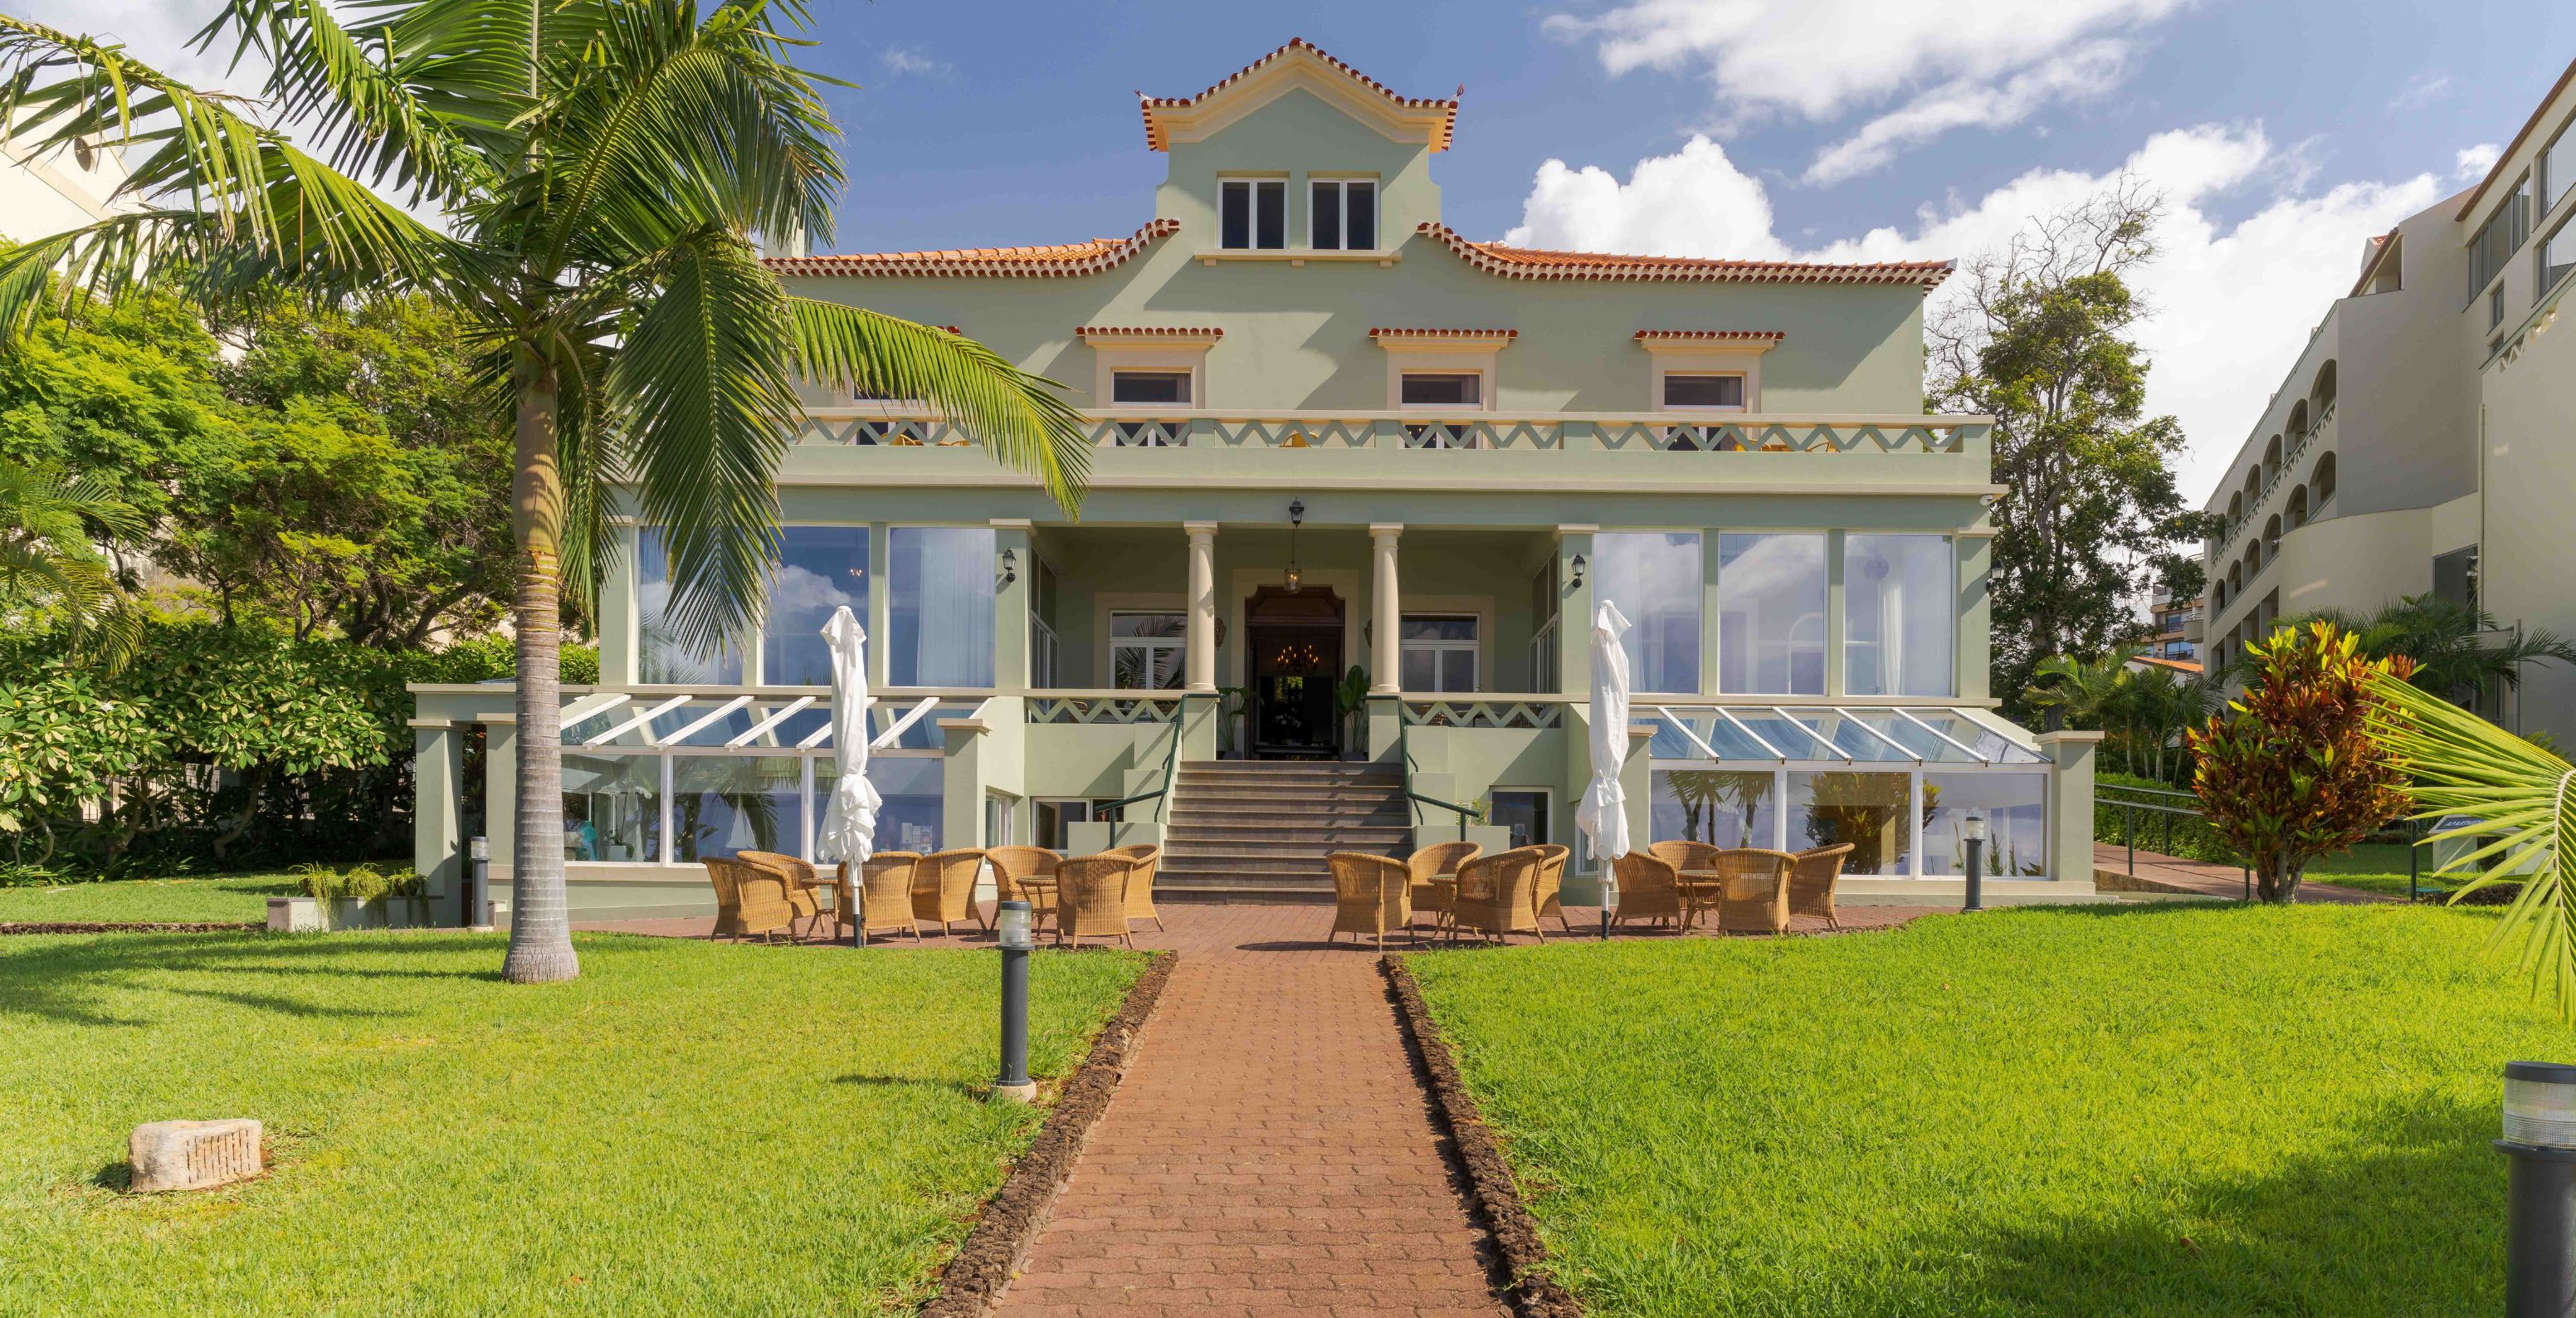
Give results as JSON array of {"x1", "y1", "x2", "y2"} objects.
[{"x1": 1545, "y1": 0, "x2": 2189, "y2": 183}]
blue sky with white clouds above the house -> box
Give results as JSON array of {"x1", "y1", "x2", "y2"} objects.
[{"x1": 16, "y1": 0, "x2": 2576, "y2": 502}]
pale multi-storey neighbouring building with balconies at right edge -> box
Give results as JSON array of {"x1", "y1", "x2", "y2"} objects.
[{"x1": 2189, "y1": 54, "x2": 2576, "y2": 744}]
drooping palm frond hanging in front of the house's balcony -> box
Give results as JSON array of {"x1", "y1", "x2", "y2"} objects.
[{"x1": 788, "y1": 299, "x2": 1092, "y2": 515}]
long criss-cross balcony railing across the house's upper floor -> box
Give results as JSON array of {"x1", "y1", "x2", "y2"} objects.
[{"x1": 793, "y1": 412, "x2": 1988, "y2": 453}]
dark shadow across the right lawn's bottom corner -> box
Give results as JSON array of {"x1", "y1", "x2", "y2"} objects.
[{"x1": 1857, "y1": 1096, "x2": 2504, "y2": 1318}]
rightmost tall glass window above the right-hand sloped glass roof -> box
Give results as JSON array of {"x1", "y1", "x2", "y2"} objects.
[{"x1": 1842, "y1": 535, "x2": 1958, "y2": 695}]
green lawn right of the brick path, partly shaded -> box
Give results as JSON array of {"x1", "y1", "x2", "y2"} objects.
[{"x1": 1409, "y1": 904, "x2": 2576, "y2": 1318}]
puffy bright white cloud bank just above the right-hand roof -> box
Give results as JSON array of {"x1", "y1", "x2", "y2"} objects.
[{"x1": 1505, "y1": 124, "x2": 2445, "y2": 500}]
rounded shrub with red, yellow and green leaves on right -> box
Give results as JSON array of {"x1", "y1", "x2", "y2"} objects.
[{"x1": 2189, "y1": 623, "x2": 2411, "y2": 904}]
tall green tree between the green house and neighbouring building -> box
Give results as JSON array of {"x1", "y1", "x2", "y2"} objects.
[{"x1": 1927, "y1": 183, "x2": 2198, "y2": 715}]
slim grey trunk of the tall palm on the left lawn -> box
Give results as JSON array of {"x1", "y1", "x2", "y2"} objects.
[{"x1": 502, "y1": 353, "x2": 583, "y2": 984}]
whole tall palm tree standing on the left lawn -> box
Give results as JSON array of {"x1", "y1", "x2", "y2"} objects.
[{"x1": 0, "y1": 0, "x2": 1087, "y2": 981}]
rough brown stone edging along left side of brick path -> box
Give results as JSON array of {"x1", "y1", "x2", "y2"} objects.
[{"x1": 920, "y1": 953, "x2": 1180, "y2": 1318}]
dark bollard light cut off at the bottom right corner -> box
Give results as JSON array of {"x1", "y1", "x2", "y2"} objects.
[{"x1": 2496, "y1": 1061, "x2": 2576, "y2": 1318}]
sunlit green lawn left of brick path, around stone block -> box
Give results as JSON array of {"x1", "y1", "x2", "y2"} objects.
[{"x1": 0, "y1": 935, "x2": 1144, "y2": 1316}]
